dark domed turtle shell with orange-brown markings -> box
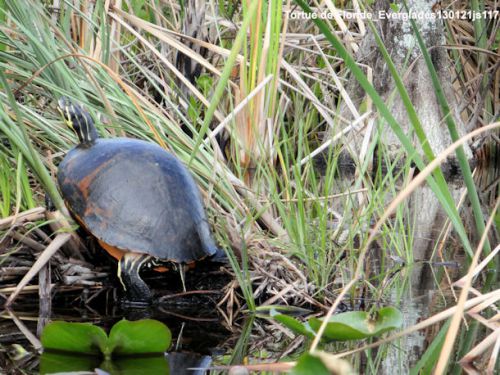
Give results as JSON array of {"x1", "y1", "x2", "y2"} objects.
[{"x1": 57, "y1": 138, "x2": 217, "y2": 263}]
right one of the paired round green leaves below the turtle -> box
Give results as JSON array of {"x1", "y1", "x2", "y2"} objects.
[{"x1": 109, "y1": 319, "x2": 172, "y2": 355}]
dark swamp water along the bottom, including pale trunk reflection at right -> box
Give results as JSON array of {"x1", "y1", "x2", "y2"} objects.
[{"x1": 0, "y1": 263, "x2": 480, "y2": 375}]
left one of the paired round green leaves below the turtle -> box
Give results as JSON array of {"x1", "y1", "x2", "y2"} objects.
[{"x1": 42, "y1": 322, "x2": 108, "y2": 355}]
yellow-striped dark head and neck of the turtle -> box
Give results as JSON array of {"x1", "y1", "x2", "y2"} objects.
[{"x1": 57, "y1": 96, "x2": 98, "y2": 144}]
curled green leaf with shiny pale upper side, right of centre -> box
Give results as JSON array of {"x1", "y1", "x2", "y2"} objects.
[{"x1": 309, "y1": 307, "x2": 403, "y2": 341}]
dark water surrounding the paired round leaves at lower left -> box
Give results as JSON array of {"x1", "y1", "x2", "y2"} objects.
[{"x1": 0, "y1": 305, "x2": 231, "y2": 375}]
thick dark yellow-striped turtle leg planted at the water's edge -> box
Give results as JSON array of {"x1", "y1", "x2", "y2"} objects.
[{"x1": 118, "y1": 253, "x2": 152, "y2": 305}]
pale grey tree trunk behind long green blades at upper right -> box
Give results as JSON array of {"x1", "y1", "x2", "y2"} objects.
[{"x1": 336, "y1": 0, "x2": 471, "y2": 260}]
